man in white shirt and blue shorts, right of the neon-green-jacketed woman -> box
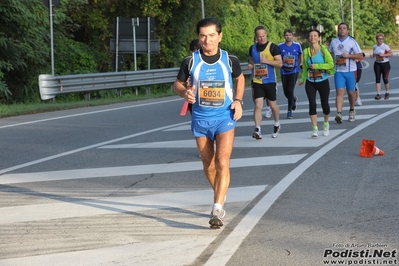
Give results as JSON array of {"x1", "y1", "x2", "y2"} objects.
[{"x1": 329, "y1": 22, "x2": 363, "y2": 124}]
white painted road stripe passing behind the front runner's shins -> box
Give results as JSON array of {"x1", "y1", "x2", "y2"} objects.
[{"x1": 0, "y1": 185, "x2": 266, "y2": 224}]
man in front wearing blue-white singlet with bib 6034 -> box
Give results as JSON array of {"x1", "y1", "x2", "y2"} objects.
[{"x1": 174, "y1": 18, "x2": 245, "y2": 228}]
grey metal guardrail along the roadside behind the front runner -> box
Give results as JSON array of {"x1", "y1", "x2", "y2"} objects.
[{"x1": 39, "y1": 63, "x2": 251, "y2": 100}]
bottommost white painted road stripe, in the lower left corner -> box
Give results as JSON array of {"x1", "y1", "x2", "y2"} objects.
[{"x1": 0, "y1": 239, "x2": 219, "y2": 266}]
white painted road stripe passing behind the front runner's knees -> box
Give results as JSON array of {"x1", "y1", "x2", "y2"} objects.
[{"x1": 0, "y1": 154, "x2": 307, "y2": 185}]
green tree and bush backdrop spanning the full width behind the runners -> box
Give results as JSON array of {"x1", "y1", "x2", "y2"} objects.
[{"x1": 0, "y1": 0, "x2": 399, "y2": 103}]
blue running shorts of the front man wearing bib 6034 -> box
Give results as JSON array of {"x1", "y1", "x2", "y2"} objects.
[{"x1": 191, "y1": 118, "x2": 237, "y2": 141}]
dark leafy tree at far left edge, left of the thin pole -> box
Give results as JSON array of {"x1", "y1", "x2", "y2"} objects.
[{"x1": 0, "y1": 0, "x2": 49, "y2": 103}]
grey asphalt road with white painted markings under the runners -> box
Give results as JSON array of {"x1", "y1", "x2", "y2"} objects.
[{"x1": 0, "y1": 57, "x2": 399, "y2": 266}]
